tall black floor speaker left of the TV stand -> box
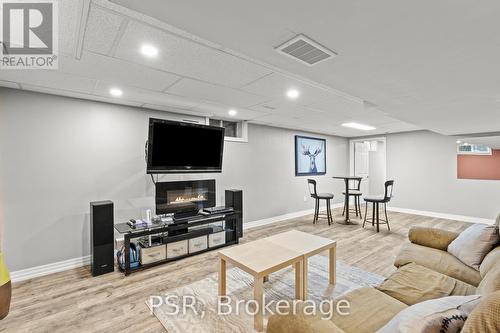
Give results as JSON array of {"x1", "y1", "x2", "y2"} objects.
[{"x1": 90, "y1": 201, "x2": 115, "y2": 276}]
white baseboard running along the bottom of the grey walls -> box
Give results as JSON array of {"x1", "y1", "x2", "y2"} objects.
[{"x1": 10, "y1": 203, "x2": 494, "y2": 282}]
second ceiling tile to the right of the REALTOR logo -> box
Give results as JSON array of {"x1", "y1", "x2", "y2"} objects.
[{"x1": 83, "y1": 4, "x2": 124, "y2": 55}]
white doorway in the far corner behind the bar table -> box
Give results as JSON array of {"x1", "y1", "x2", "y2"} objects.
[{"x1": 349, "y1": 137, "x2": 387, "y2": 195}]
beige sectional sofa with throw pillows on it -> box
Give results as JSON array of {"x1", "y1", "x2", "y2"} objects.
[{"x1": 267, "y1": 227, "x2": 500, "y2": 333}]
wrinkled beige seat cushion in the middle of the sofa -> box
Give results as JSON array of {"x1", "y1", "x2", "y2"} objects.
[{"x1": 377, "y1": 263, "x2": 476, "y2": 305}]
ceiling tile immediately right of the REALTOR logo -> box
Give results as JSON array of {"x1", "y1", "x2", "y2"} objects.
[{"x1": 59, "y1": 0, "x2": 83, "y2": 55}]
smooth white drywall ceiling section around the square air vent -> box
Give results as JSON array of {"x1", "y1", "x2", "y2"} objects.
[{"x1": 112, "y1": 0, "x2": 500, "y2": 134}]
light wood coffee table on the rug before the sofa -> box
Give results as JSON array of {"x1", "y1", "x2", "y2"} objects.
[{"x1": 219, "y1": 230, "x2": 337, "y2": 332}]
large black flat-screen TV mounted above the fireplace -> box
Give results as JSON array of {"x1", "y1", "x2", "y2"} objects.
[{"x1": 147, "y1": 118, "x2": 224, "y2": 174}]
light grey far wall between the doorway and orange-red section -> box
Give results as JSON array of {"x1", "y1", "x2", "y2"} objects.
[{"x1": 387, "y1": 131, "x2": 500, "y2": 219}]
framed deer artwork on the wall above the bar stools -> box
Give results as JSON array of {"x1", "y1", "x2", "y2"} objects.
[{"x1": 295, "y1": 135, "x2": 326, "y2": 176}]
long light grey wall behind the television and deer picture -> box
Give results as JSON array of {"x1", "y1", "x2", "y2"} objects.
[{"x1": 0, "y1": 88, "x2": 348, "y2": 271}]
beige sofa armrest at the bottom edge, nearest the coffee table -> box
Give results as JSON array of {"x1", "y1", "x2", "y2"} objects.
[{"x1": 266, "y1": 313, "x2": 345, "y2": 333}]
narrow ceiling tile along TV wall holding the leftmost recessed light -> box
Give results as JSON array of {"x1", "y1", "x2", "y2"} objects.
[{"x1": 94, "y1": 81, "x2": 198, "y2": 110}]
